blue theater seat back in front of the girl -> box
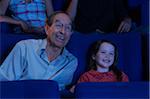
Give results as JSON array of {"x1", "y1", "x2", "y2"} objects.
[{"x1": 75, "y1": 82, "x2": 149, "y2": 99}]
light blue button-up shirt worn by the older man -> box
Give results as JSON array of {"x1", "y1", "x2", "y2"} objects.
[{"x1": 0, "y1": 39, "x2": 77, "y2": 90}]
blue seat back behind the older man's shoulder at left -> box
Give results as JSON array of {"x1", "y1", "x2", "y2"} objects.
[{"x1": 0, "y1": 23, "x2": 44, "y2": 64}]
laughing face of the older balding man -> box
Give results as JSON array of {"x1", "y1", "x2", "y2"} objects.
[{"x1": 46, "y1": 13, "x2": 72, "y2": 48}]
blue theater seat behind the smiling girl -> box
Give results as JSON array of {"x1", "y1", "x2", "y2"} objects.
[{"x1": 67, "y1": 32, "x2": 142, "y2": 84}]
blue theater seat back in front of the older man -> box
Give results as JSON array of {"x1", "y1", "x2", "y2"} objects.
[{"x1": 0, "y1": 80, "x2": 60, "y2": 99}]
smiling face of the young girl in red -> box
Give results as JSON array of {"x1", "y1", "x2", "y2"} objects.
[{"x1": 93, "y1": 42, "x2": 115, "y2": 68}]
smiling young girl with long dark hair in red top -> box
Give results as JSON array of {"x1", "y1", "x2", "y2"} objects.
[{"x1": 78, "y1": 40, "x2": 129, "y2": 83}]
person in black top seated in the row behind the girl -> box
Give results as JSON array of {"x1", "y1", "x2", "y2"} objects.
[{"x1": 67, "y1": 0, "x2": 131, "y2": 33}]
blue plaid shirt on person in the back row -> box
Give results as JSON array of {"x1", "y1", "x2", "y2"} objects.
[{"x1": 9, "y1": 0, "x2": 46, "y2": 27}]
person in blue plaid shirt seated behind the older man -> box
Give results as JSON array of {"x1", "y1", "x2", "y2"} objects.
[{"x1": 0, "y1": 0, "x2": 53, "y2": 35}]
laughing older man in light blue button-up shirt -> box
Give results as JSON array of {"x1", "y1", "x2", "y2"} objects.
[{"x1": 0, "y1": 12, "x2": 78, "y2": 90}]
